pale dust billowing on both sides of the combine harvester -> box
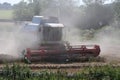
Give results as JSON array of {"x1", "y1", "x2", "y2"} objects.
[{"x1": 0, "y1": 23, "x2": 120, "y2": 62}]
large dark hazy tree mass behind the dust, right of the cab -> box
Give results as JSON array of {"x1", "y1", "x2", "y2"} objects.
[{"x1": 76, "y1": 3, "x2": 114, "y2": 29}]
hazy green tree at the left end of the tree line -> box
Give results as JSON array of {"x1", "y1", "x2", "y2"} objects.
[{"x1": 14, "y1": 1, "x2": 33, "y2": 21}]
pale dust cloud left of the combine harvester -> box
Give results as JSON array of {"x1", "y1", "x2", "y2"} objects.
[{"x1": 0, "y1": 23, "x2": 39, "y2": 61}]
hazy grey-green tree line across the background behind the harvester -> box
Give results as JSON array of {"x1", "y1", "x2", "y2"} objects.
[{"x1": 14, "y1": 0, "x2": 120, "y2": 29}]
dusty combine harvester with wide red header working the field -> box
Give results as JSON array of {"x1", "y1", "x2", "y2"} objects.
[{"x1": 23, "y1": 16, "x2": 100, "y2": 63}]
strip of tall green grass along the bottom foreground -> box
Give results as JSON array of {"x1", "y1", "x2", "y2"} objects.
[{"x1": 0, "y1": 64, "x2": 120, "y2": 80}]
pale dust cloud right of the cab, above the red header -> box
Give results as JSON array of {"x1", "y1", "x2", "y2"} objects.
[{"x1": 64, "y1": 22, "x2": 120, "y2": 62}]
